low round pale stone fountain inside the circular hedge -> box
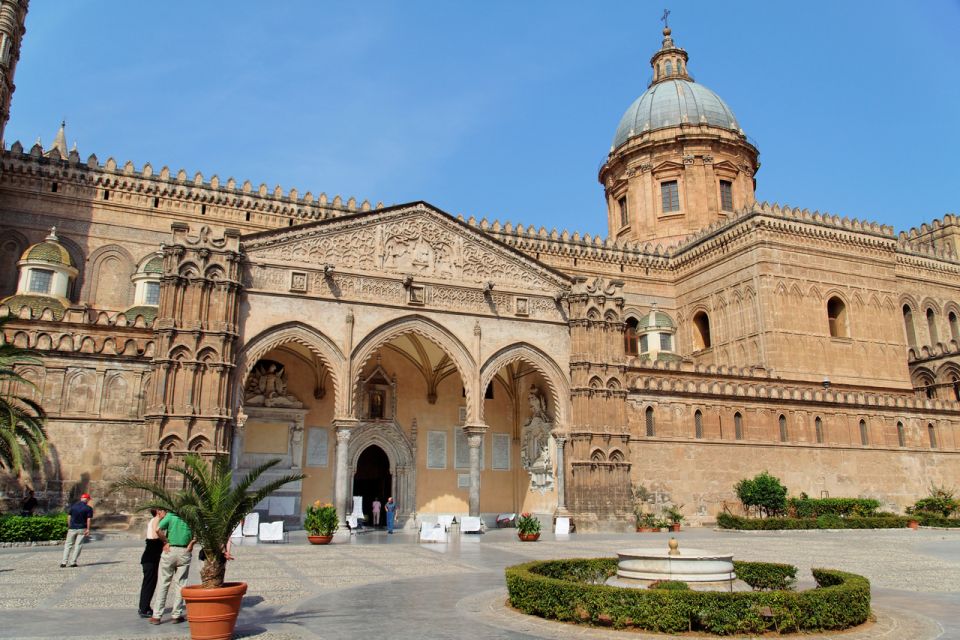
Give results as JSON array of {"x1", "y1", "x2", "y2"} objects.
[{"x1": 607, "y1": 538, "x2": 737, "y2": 591}]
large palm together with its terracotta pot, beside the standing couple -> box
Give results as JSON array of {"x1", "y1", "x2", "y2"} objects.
[{"x1": 114, "y1": 453, "x2": 306, "y2": 640}]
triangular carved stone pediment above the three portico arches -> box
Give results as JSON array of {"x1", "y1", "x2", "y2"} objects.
[{"x1": 242, "y1": 202, "x2": 570, "y2": 294}]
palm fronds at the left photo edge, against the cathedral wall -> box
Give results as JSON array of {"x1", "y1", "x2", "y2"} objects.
[{"x1": 0, "y1": 316, "x2": 47, "y2": 474}]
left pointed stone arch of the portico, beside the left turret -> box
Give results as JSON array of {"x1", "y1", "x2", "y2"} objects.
[{"x1": 231, "y1": 321, "x2": 348, "y2": 417}]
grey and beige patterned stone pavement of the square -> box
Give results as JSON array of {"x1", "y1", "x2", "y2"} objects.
[{"x1": 0, "y1": 529, "x2": 960, "y2": 640}]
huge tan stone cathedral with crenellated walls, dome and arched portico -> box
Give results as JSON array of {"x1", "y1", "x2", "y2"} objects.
[{"x1": 0, "y1": 0, "x2": 960, "y2": 530}]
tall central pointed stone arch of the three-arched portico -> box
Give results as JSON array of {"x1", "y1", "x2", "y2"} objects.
[{"x1": 347, "y1": 315, "x2": 474, "y2": 422}]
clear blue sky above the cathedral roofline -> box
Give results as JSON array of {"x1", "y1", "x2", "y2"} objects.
[{"x1": 6, "y1": 0, "x2": 960, "y2": 235}]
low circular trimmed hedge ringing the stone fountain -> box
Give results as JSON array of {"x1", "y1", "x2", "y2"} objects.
[{"x1": 506, "y1": 558, "x2": 870, "y2": 635}]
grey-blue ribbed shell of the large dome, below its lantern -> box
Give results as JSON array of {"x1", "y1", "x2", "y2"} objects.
[{"x1": 613, "y1": 78, "x2": 740, "y2": 148}]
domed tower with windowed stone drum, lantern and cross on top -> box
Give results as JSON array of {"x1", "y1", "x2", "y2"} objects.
[{"x1": 598, "y1": 23, "x2": 760, "y2": 246}]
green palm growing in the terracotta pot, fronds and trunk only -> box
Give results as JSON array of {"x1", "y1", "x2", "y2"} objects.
[{"x1": 114, "y1": 453, "x2": 306, "y2": 589}]
